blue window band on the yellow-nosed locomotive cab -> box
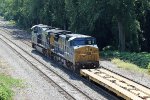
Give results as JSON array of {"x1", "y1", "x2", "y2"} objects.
[{"x1": 71, "y1": 38, "x2": 96, "y2": 46}]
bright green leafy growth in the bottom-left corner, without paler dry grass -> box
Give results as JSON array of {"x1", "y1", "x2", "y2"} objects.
[{"x1": 0, "y1": 74, "x2": 21, "y2": 100}]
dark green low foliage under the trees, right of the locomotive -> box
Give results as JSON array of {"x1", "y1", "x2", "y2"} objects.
[{"x1": 101, "y1": 51, "x2": 150, "y2": 69}]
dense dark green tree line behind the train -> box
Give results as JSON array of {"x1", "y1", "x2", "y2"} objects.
[{"x1": 0, "y1": 0, "x2": 150, "y2": 52}]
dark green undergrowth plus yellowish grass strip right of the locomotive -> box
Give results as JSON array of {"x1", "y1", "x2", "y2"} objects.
[{"x1": 101, "y1": 51, "x2": 150, "y2": 74}]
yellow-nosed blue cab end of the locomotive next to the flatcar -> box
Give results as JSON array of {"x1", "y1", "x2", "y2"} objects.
[{"x1": 69, "y1": 34, "x2": 99, "y2": 69}]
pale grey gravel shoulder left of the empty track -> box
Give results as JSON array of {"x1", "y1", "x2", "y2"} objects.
[{"x1": 0, "y1": 36, "x2": 66, "y2": 100}]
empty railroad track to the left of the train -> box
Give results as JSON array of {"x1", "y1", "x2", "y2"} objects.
[{"x1": 0, "y1": 34, "x2": 93, "y2": 100}]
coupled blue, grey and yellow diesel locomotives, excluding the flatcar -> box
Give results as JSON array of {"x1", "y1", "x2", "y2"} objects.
[{"x1": 31, "y1": 24, "x2": 99, "y2": 71}]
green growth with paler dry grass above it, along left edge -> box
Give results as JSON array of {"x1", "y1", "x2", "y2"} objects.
[{"x1": 0, "y1": 58, "x2": 23, "y2": 100}]
